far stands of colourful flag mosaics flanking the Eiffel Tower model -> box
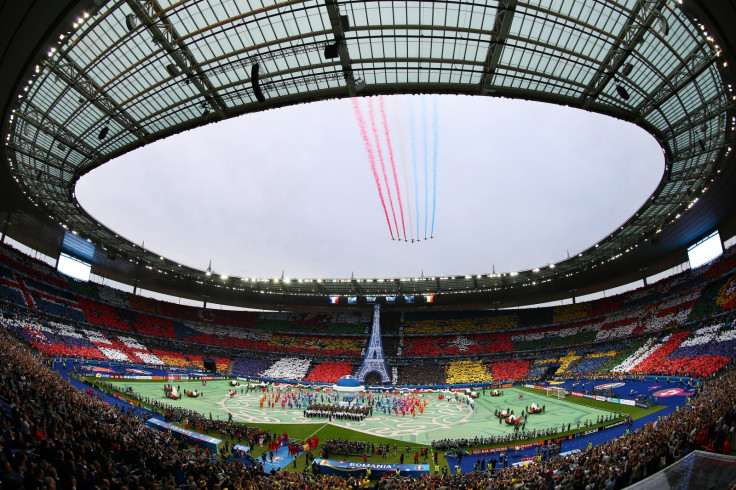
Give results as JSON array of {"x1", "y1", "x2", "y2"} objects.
[{"x1": 0, "y1": 241, "x2": 736, "y2": 384}]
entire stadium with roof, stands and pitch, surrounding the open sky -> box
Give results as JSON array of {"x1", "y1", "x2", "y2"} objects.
[{"x1": 0, "y1": 0, "x2": 736, "y2": 488}]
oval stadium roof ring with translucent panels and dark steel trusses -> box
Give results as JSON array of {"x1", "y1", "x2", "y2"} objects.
[{"x1": 0, "y1": 0, "x2": 736, "y2": 308}]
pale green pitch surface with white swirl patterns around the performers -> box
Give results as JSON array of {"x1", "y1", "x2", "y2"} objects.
[{"x1": 105, "y1": 380, "x2": 620, "y2": 445}]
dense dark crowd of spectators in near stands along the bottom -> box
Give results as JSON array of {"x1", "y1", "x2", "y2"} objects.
[{"x1": 0, "y1": 320, "x2": 736, "y2": 489}]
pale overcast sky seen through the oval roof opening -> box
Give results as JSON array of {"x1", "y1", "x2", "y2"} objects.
[{"x1": 76, "y1": 96, "x2": 664, "y2": 278}]
